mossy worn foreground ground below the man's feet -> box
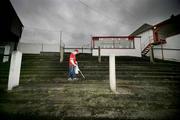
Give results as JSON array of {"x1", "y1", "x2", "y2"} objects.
[{"x1": 0, "y1": 80, "x2": 180, "y2": 120}]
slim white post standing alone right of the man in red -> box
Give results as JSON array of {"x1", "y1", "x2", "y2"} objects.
[{"x1": 109, "y1": 55, "x2": 116, "y2": 93}]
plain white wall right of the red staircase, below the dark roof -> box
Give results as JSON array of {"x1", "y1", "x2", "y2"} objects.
[{"x1": 154, "y1": 34, "x2": 180, "y2": 62}]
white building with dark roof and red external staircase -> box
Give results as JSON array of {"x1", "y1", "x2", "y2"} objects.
[{"x1": 131, "y1": 15, "x2": 180, "y2": 62}]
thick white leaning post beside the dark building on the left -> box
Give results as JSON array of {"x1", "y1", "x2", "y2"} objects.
[{"x1": 8, "y1": 51, "x2": 22, "y2": 90}]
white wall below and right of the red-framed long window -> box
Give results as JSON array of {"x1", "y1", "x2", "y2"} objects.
[{"x1": 93, "y1": 38, "x2": 141, "y2": 57}]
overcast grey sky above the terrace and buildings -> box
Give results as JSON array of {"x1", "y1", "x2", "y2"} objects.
[{"x1": 11, "y1": 0, "x2": 180, "y2": 46}]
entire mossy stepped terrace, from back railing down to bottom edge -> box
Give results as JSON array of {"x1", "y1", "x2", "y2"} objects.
[{"x1": 0, "y1": 53, "x2": 180, "y2": 120}]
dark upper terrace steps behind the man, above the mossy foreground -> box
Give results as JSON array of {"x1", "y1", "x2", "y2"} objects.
[{"x1": 21, "y1": 53, "x2": 180, "y2": 80}]
